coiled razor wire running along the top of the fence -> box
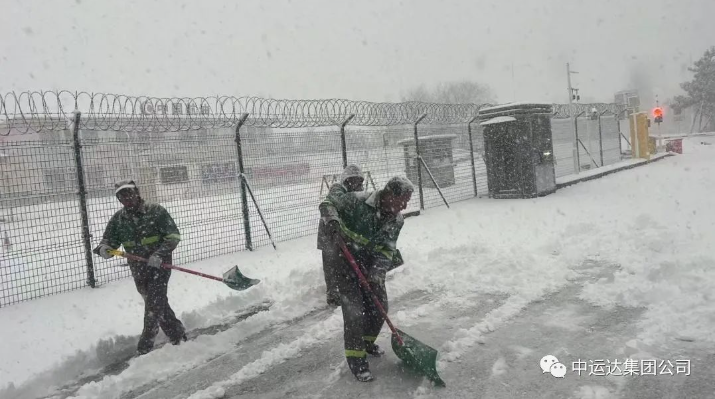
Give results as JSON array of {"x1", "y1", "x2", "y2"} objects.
[{"x1": 0, "y1": 90, "x2": 615, "y2": 136}]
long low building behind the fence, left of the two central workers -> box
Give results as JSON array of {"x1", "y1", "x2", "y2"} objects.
[{"x1": 0, "y1": 118, "x2": 328, "y2": 209}]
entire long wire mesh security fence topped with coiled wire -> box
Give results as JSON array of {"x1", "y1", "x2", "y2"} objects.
[{"x1": 0, "y1": 92, "x2": 620, "y2": 306}]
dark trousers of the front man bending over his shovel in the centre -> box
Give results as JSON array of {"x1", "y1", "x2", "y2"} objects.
[{"x1": 336, "y1": 250, "x2": 388, "y2": 359}]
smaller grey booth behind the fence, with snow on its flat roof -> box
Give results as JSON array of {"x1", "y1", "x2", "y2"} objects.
[{"x1": 398, "y1": 134, "x2": 457, "y2": 188}]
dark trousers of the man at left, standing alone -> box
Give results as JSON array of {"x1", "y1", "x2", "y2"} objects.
[{"x1": 129, "y1": 259, "x2": 185, "y2": 354}]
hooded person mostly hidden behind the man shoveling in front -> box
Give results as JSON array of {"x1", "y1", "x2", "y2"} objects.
[{"x1": 318, "y1": 164, "x2": 365, "y2": 306}]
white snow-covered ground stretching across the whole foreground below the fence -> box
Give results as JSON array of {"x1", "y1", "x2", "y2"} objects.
[{"x1": 0, "y1": 137, "x2": 715, "y2": 398}]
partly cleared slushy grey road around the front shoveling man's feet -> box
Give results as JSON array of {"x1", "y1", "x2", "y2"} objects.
[{"x1": 117, "y1": 261, "x2": 715, "y2": 399}]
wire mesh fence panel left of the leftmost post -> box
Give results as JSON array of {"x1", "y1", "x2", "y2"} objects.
[{"x1": 0, "y1": 140, "x2": 87, "y2": 305}]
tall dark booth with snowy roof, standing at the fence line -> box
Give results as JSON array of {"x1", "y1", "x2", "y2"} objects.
[{"x1": 479, "y1": 104, "x2": 556, "y2": 198}]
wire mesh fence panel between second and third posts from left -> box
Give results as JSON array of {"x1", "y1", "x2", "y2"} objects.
[{"x1": 242, "y1": 127, "x2": 342, "y2": 246}]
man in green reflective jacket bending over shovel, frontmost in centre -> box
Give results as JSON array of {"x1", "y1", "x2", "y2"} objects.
[{"x1": 320, "y1": 177, "x2": 414, "y2": 381}]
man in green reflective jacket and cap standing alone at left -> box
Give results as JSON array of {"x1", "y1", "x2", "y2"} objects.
[{"x1": 95, "y1": 180, "x2": 186, "y2": 355}]
